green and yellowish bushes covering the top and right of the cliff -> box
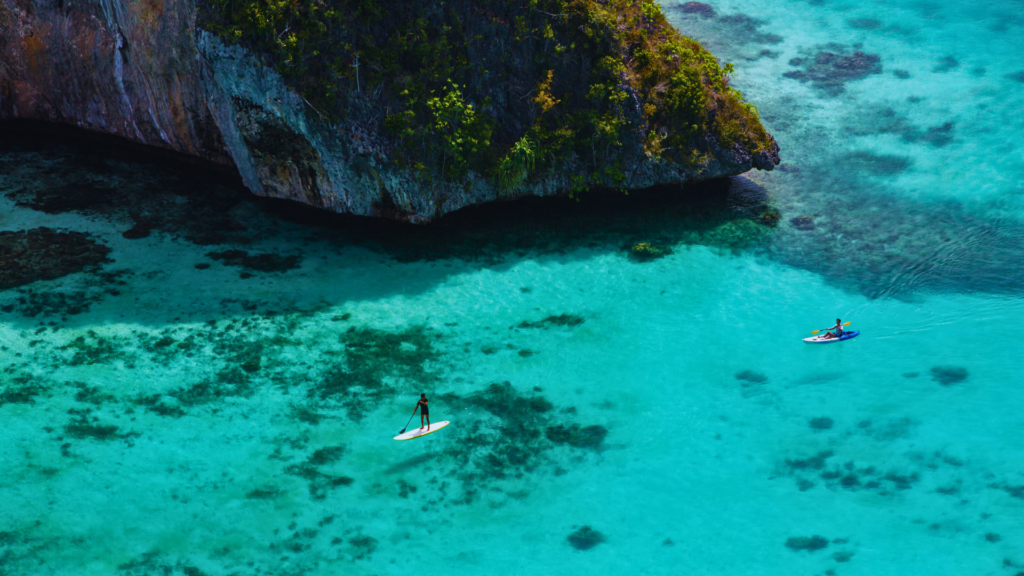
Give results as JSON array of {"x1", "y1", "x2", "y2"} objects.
[{"x1": 199, "y1": 0, "x2": 773, "y2": 190}]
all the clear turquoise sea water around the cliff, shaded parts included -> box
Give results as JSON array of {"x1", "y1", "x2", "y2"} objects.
[{"x1": 0, "y1": 1, "x2": 1024, "y2": 576}]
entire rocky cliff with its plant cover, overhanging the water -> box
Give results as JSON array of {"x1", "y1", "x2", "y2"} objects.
[{"x1": 0, "y1": 0, "x2": 779, "y2": 221}]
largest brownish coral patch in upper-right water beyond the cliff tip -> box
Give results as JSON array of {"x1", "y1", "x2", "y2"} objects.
[{"x1": 783, "y1": 44, "x2": 882, "y2": 96}]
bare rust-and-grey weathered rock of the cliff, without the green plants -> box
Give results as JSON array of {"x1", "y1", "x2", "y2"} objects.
[{"x1": 0, "y1": 0, "x2": 779, "y2": 220}]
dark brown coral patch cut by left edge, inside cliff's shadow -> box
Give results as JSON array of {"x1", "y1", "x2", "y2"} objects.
[{"x1": 0, "y1": 228, "x2": 111, "y2": 290}]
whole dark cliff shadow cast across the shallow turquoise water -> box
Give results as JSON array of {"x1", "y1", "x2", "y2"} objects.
[{"x1": 0, "y1": 122, "x2": 777, "y2": 326}]
